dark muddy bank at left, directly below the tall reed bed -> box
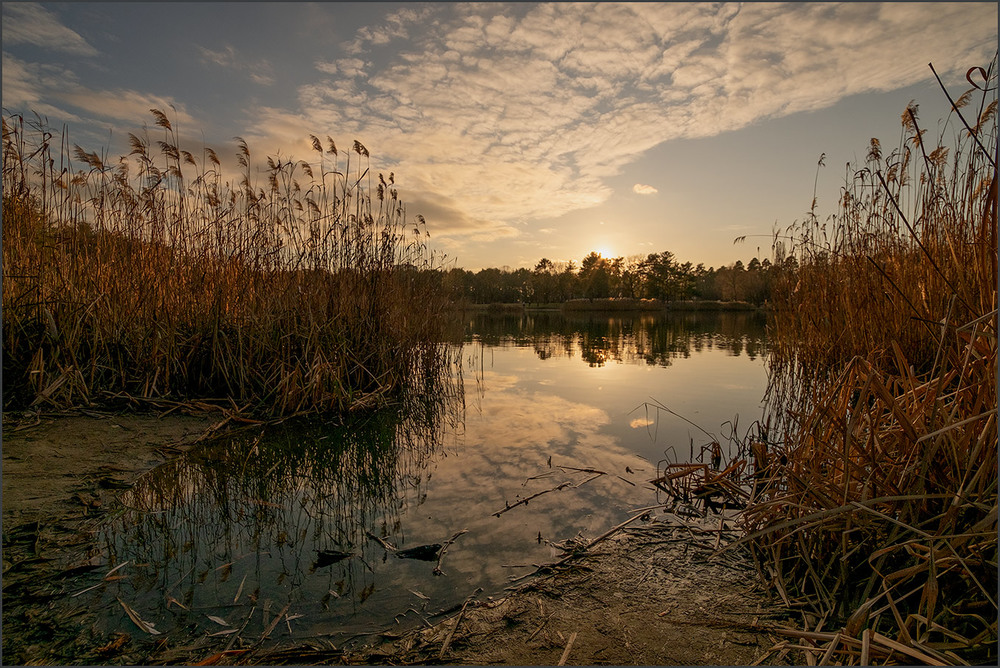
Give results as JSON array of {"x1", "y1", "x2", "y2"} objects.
[{"x1": 3, "y1": 409, "x2": 218, "y2": 665}]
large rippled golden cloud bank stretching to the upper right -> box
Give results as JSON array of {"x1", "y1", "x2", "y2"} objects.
[{"x1": 244, "y1": 3, "x2": 996, "y2": 243}]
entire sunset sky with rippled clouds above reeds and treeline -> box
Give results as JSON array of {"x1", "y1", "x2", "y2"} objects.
[{"x1": 2, "y1": 2, "x2": 998, "y2": 270}]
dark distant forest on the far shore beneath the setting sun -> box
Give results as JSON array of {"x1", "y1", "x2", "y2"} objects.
[{"x1": 438, "y1": 249, "x2": 796, "y2": 305}]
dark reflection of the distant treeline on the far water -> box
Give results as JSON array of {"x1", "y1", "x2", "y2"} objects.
[{"x1": 466, "y1": 311, "x2": 767, "y2": 367}]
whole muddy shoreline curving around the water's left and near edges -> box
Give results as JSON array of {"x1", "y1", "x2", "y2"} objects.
[{"x1": 3, "y1": 410, "x2": 781, "y2": 665}]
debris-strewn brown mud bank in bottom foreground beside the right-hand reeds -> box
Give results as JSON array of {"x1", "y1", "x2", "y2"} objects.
[{"x1": 359, "y1": 522, "x2": 782, "y2": 665}]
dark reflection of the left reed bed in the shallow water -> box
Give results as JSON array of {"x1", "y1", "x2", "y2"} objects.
[{"x1": 94, "y1": 362, "x2": 462, "y2": 637}]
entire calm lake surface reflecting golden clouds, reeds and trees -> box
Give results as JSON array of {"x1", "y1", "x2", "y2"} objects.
[{"x1": 90, "y1": 313, "x2": 766, "y2": 646}]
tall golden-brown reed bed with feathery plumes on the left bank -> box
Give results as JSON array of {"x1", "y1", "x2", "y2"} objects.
[{"x1": 3, "y1": 109, "x2": 452, "y2": 415}]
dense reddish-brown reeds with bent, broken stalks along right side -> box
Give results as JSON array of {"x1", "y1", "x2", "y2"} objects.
[{"x1": 741, "y1": 61, "x2": 997, "y2": 664}]
